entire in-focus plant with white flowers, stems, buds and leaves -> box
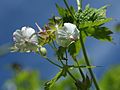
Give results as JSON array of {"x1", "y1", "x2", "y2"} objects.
[{"x1": 11, "y1": 0, "x2": 112, "y2": 90}]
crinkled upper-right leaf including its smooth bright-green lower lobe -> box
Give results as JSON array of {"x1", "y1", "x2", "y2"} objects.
[{"x1": 75, "y1": 4, "x2": 111, "y2": 25}]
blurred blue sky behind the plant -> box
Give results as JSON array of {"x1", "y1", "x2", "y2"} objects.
[{"x1": 0, "y1": 0, "x2": 120, "y2": 87}]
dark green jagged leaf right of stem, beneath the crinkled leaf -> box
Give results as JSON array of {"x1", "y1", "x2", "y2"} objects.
[{"x1": 87, "y1": 27, "x2": 113, "y2": 41}]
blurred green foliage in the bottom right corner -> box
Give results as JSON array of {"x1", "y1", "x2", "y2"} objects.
[{"x1": 100, "y1": 65, "x2": 120, "y2": 90}]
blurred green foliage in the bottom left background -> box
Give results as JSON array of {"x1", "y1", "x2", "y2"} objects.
[{"x1": 7, "y1": 71, "x2": 40, "y2": 90}]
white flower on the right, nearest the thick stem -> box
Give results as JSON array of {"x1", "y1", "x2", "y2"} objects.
[{"x1": 56, "y1": 23, "x2": 79, "y2": 47}]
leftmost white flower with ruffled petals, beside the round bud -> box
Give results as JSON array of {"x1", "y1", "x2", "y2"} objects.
[{"x1": 13, "y1": 27, "x2": 38, "y2": 52}]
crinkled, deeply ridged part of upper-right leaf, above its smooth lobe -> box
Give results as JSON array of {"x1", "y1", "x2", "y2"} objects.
[{"x1": 76, "y1": 4, "x2": 107, "y2": 23}]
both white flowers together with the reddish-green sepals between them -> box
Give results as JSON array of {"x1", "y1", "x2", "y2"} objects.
[{"x1": 13, "y1": 23, "x2": 79, "y2": 52}]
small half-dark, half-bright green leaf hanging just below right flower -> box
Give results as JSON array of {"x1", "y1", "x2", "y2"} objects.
[{"x1": 68, "y1": 40, "x2": 81, "y2": 56}]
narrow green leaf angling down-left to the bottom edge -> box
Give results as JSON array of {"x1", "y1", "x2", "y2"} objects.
[{"x1": 45, "y1": 70, "x2": 63, "y2": 90}]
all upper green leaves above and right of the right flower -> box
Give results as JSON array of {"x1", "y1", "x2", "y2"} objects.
[{"x1": 56, "y1": 4, "x2": 112, "y2": 42}]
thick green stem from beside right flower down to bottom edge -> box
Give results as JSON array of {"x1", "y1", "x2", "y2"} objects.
[{"x1": 80, "y1": 31, "x2": 100, "y2": 90}]
